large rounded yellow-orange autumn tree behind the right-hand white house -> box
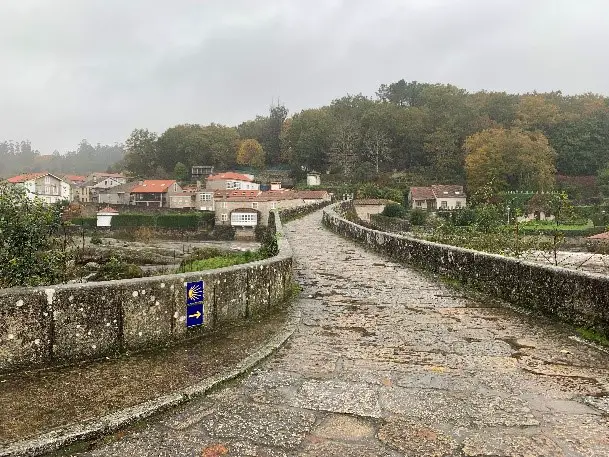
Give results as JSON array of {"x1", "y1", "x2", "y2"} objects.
[{"x1": 464, "y1": 128, "x2": 556, "y2": 193}]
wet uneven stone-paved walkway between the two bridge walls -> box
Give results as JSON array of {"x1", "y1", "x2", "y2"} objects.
[{"x1": 66, "y1": 213, "x2": 609, "y2": 457}]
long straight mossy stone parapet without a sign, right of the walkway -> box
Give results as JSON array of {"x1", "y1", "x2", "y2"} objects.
[{"x1": 323, "y1": 205, "x2": 609, "y2": 336}]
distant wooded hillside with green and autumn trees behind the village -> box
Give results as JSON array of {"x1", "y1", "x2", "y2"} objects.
[{"x1": 7, "y1": 80, "x2": 609, "y2": 198}]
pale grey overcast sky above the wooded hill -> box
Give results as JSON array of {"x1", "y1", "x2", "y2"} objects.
[{"x1": 0, "y1": 0, "x2": 609, "y2": 153}]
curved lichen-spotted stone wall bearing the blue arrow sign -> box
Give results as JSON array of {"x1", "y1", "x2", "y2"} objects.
[{"x1": 0, "y1": 212, "x2": 293, "y2": 372}]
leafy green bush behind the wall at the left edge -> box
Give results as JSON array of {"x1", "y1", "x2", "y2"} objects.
[{"x1": 0, "y1": 183, "x2": 66, "y2": 287}]
